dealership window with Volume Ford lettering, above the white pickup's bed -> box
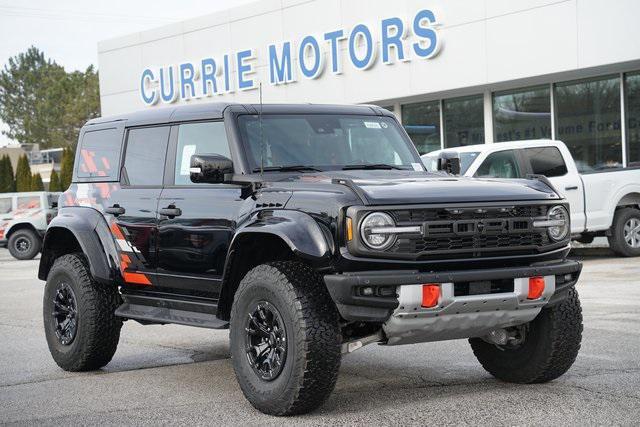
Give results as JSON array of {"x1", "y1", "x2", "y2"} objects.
[{"x1": 554, "y1": 77, "x2": 622, "y2": 172}]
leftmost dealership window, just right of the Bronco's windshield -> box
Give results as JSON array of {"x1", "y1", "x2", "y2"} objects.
[{"x1": 402, "y1": 101, "x2": 442, "y2": 154}]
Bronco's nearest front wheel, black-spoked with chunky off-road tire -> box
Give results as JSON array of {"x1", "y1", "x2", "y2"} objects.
[{"x1": 230, "y1": 261, "x2": 342, "y2": 415}]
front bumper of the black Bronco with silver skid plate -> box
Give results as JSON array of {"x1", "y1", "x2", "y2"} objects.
[{"x1": 324, "y1": 260, "x2": 582, "y2": 344}]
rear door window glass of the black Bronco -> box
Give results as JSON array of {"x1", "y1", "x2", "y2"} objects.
[{"x1": 123, "y1": 126, "x2": 170, "y2": 185}]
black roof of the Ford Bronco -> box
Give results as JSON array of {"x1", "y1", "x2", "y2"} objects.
[{"x1": 87, "y1": 102, "x2": 393, "y2": 126}]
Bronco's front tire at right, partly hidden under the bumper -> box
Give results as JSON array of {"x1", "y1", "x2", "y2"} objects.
[{"x1": 469, "y1": 289, "x2": 582, "y2": 384}]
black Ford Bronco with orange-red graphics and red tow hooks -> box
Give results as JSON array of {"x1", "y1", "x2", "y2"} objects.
[{"x1": 39, "y1": 104, "x2": 582, "y2": 415}]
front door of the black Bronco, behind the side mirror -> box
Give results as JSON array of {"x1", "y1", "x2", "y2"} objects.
[{"x1": 158, "y1": 122, "x2": 242, "y2": 298}]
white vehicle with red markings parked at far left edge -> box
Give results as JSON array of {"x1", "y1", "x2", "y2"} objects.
[{"x1": 0, "y1": 191, "x2": 60, "y2": 259}]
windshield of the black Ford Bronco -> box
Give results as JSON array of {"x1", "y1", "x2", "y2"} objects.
[{"x1": 238, "y1": 114, "x2": 424, "y2": 172}]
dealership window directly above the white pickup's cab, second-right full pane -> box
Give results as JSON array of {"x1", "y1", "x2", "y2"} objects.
[{"x1": 493, "y1": 86, "x2": 551, "y2": 142}]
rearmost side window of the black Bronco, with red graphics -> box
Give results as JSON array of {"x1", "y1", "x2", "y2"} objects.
[{"x1": 76, "y1": 128, "x2": 122, "y2": 181}]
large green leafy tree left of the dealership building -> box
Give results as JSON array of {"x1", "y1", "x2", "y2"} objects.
[{"x1": 0, "y1": 46, "x2": 100, "y2": 148}]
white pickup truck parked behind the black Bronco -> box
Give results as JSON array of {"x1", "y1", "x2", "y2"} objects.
[{"x1": 422, "y1": 140, "x2": 640, "y2": 256}]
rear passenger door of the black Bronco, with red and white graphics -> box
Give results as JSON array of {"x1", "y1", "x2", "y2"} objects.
[{"x1": 105, "y1": 126, "x2": 170, "y2": 288}]
